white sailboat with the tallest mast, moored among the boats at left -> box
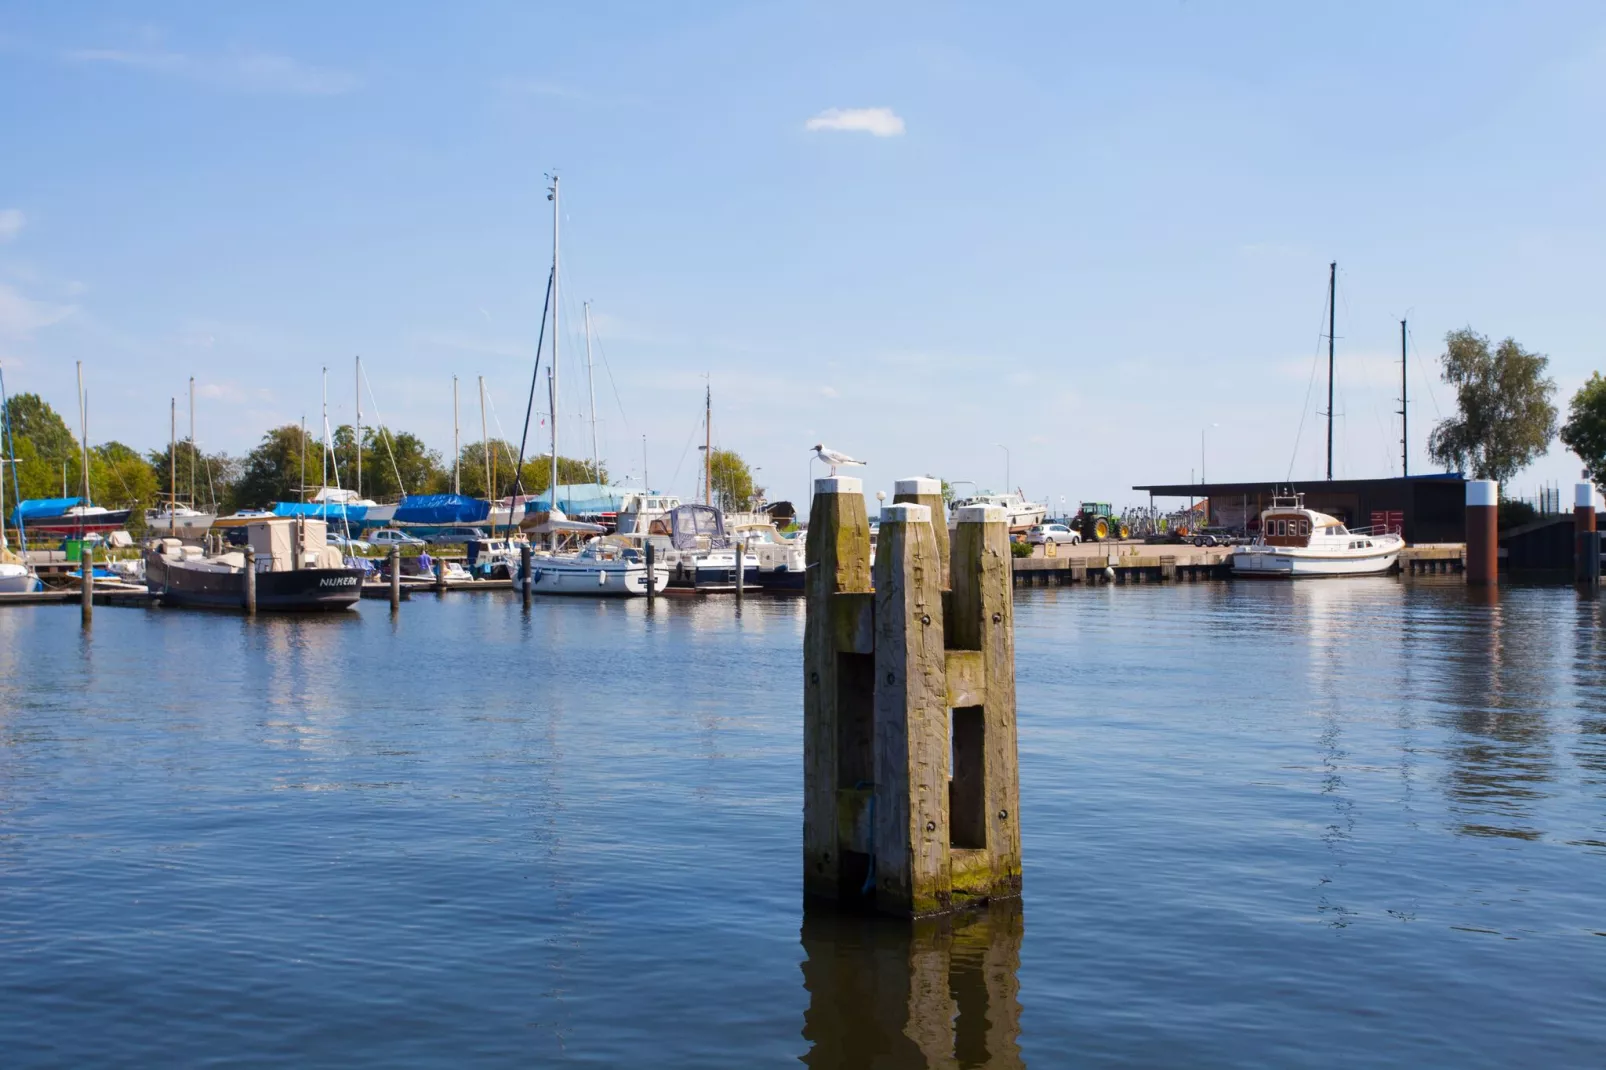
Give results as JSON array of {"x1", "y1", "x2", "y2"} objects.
[{"x1": 520, "y1": 175, "x2": 670, "y2": 598}]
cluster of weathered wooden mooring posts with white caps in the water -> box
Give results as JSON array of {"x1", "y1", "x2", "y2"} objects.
[{"x1": 803, "y1": 477, "x2": 1020, "y2": 917}]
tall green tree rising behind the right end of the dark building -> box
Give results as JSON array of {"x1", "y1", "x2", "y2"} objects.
[{"x1": 1428, "y1": 328, "x2": 1556, "y2": 484}]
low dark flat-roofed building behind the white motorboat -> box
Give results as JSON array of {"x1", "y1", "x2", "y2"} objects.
[{"x1": 1132, "y1": 474, "x2": 1466, "y2": 543}]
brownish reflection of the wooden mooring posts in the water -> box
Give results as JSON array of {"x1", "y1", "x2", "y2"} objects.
[{"x1": 803, "y1": 900, "x2": 1026, "y2": 1070}]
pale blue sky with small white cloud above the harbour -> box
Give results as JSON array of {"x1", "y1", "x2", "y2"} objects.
[{"x1": 0, "y1": 0, "x2": 1606, "y2": 503}]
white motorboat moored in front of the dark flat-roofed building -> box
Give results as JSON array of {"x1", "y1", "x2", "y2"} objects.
[{"x1": 1232, "y1": 495, "x2": 1405, "y2": 578}]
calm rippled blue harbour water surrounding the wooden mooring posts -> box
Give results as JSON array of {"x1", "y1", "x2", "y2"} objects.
[{"x1": 0, "y1": 580, "x2": 1606, "y2": 1067}]
